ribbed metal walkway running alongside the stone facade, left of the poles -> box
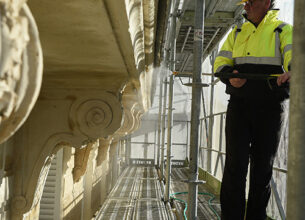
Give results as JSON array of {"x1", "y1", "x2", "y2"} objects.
[{"x1": 95, "y1": 166, "x2": 168, "y2": 220}]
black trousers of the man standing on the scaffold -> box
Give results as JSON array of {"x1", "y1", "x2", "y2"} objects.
[{"x1": 220, "y1": 97, "x2": 282, "y2": 220}]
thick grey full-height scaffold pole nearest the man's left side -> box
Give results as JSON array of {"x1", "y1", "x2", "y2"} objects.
[{"x1": 187, "y1": 0, "x2": 205, "y2": 217}]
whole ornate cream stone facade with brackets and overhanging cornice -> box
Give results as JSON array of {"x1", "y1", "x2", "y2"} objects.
[{"x1": 0, "y1": 0, "x2": 158, "y2": 220}]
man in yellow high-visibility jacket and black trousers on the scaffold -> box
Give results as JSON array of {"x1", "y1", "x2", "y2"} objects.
[{"x1": 214, "y1": 0, "x2": 292, "y2": 220}]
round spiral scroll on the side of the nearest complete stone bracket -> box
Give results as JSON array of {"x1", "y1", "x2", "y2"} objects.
[{"x1": 70, "y1": 92, "x2": 123, "y2": 140}]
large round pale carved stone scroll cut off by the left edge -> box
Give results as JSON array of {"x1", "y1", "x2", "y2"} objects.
[{"x1": 0, "y1": 0, "x2": 43, "y2": 143}]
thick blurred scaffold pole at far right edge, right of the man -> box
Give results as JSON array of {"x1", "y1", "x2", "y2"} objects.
[{"x1": 287, "y1": 0, "x2": 305, "y2": 219}]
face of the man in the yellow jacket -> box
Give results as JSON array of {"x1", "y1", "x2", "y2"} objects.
[{"x1": 244, "y1": 0, "x2": 270, "y2": 25}]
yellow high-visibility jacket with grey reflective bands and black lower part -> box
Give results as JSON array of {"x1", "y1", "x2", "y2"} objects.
[{"x1": 214, "y1": 10, "x2": 293, "y2": 100}]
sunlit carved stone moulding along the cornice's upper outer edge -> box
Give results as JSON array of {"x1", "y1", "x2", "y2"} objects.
[{"x1": 121, "y1": 0, "x2": 158, "y2": 111}]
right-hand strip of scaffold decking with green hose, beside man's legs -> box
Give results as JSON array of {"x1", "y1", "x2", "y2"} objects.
[{"x1": 171, "y1": 168, "x2": 221, "y2": 220}]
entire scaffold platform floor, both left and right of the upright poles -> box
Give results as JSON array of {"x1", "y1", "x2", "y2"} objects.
[{"x1": 95, "y1": 166, "x2": 221, "y2": 220}]
